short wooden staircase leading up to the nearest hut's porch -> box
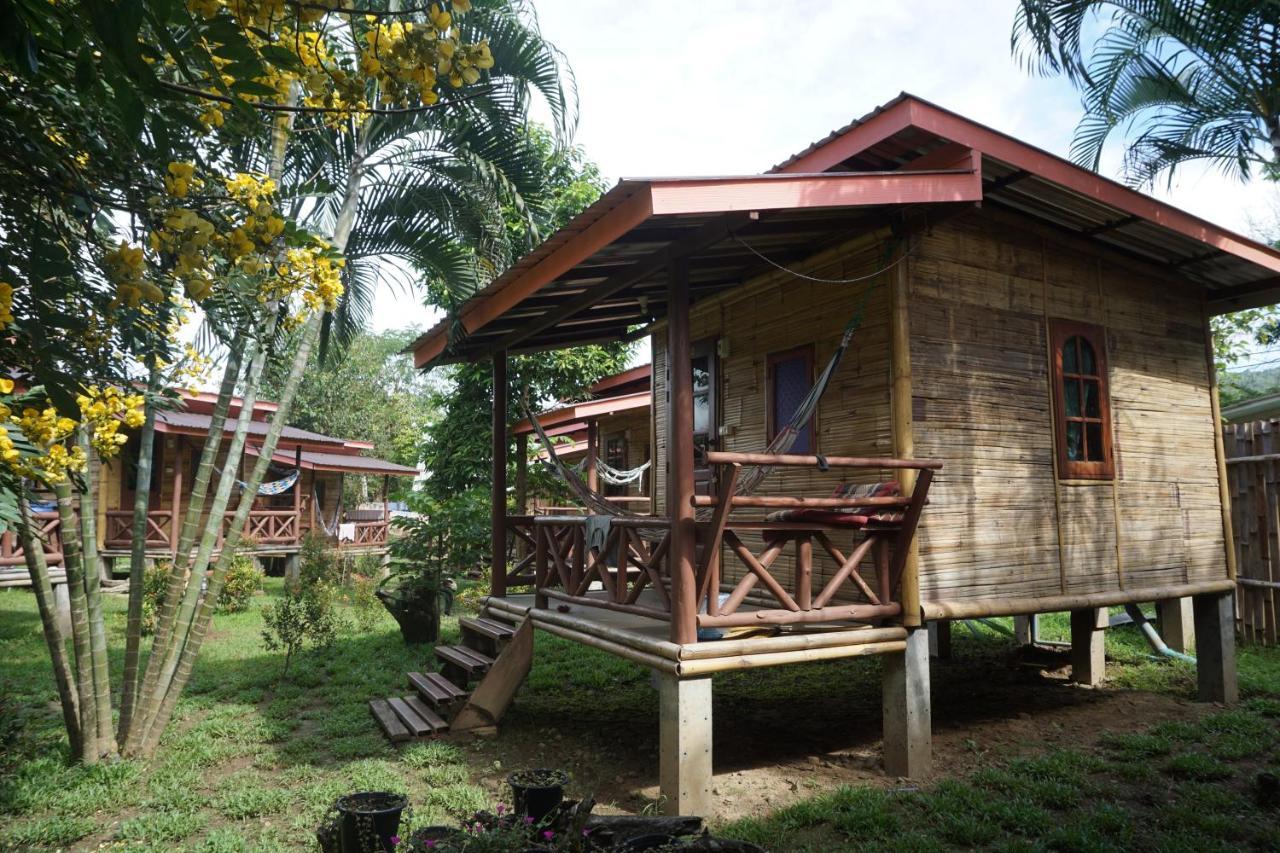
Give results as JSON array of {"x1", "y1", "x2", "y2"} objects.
[{"x1": 369, "y1": 604, "x2": 534, "y2": 743}]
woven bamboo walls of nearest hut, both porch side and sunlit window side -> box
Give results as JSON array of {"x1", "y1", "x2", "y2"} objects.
[{"x1": 652, "y1": 210, "x2": 1228, "y2": 612}]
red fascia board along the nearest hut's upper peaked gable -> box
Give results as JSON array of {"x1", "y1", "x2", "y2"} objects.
[{"x1": 780, "y1": 96, "x2": 1280, "y2": 272}]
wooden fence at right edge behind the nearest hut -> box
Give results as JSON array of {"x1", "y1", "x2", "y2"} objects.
[{"x1": 1222, "y1": 419, "x2": 1280, "y2": 646}]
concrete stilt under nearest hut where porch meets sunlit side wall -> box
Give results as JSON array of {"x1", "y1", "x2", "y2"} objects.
[{"x1": 882, "y1": 629, "x2": 933, "y2": 779}]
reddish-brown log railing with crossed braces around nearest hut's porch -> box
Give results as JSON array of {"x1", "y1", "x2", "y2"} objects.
[{"x1": 507, "y1": 452, "x2": 942, "y2": 637}]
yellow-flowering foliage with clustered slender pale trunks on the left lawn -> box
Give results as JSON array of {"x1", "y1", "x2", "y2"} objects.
[{"x1": 0, "y1": 0, "x2": 568, "y2": 762}]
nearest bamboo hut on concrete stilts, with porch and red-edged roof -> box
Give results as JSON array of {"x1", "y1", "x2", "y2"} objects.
[{"x1": 415, "y1": 95, "x2": 1280, "y2": 813}]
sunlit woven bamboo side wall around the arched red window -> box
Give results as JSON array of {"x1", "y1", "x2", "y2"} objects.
[{"x1": 910, "y1": 211, "x2": 1226, "y2": 602}]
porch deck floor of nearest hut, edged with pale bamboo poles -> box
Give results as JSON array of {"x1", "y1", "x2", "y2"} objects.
[{"x1": 485, "y1": 589, "x2": 906, "y2": 678}]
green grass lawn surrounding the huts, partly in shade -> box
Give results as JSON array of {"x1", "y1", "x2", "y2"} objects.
[{"x1": 0, "y1": 580, "x2": 1280, "y2": 850}]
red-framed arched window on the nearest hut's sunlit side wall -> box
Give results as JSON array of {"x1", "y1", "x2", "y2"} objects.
[{"x1": 1050, "y1": 320, "x2": 1115, "y2": 480}]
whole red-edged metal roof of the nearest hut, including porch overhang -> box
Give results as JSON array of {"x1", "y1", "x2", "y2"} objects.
[{"x1": 412, "y1": 95, "x2": 1280, "y2": 366}]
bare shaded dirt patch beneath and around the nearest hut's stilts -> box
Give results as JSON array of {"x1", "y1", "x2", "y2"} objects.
[{"x1": 457, "y1": 640, "x2": 1215, "y2": 821}]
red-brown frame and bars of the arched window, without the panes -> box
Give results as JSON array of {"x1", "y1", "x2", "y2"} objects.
[{"x1": 1048, "y1": 319, "x2": 1115, "y2": 480}]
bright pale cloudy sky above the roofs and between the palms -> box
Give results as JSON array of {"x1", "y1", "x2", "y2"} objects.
[{"x1": 375, "y1": 0, "x2": 1280, "y2": 338}]
